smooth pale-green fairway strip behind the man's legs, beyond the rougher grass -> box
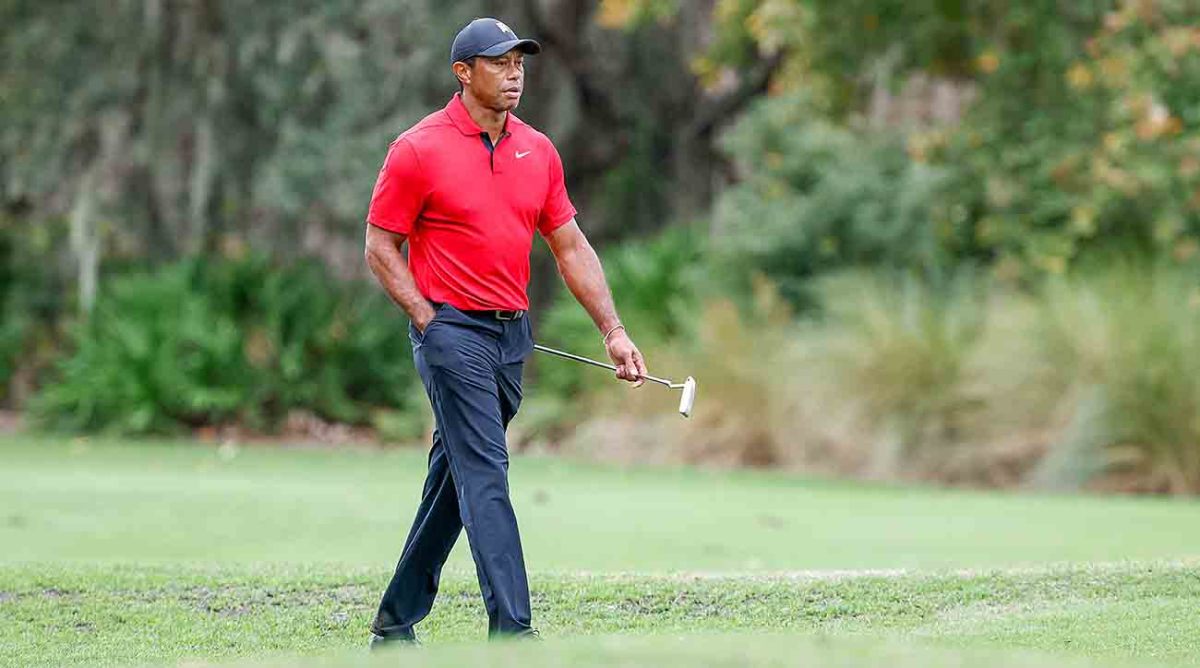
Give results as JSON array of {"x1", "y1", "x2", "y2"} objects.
[{"x1": 0, "y1": 438, "x2": 1200, "y2": 573}]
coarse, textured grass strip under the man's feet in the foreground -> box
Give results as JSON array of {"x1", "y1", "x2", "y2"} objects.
[{"x1": 0, "y1": 564, "x2": 1200, "y2": 666}]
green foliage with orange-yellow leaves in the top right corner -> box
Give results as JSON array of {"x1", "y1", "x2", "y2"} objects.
[{"x1": 918, "y1": 1, "x2": 1200, "y2": 272}]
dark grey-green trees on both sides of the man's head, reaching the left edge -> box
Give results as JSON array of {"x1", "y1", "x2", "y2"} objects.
[{"x1": 0, "y1": 0, "x2": 768, "y2": 287}]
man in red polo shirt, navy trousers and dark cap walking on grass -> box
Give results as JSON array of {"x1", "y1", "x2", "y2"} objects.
[{"x1": 366, "y1": 18, "x2": 647, "y2": 648}]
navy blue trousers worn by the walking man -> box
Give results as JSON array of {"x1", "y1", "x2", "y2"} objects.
[{"x1": 371, "y1": 305, "x2": 533, "y2": 638}]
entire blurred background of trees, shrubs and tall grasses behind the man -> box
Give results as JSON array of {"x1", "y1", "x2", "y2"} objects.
[{"x1": 0, "y1": 0, "x2": 1200, "y2": 493}]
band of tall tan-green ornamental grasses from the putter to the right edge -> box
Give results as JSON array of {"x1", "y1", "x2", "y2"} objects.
[{"x1": 554, "y1": 264, "x2": 1200, "y2": 493}]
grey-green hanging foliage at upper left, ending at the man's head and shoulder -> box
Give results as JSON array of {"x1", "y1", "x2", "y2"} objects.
[{"x1": 0, "y1": 0, "x2": 481, "y2": 259}]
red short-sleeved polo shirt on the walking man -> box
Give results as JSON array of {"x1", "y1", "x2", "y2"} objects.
[{"x1": 367, "y1": 95, "x2": 575, "y2": 309}]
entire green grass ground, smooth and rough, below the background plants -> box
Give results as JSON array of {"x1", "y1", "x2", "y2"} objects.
[{"x1": 0, "y1": 437, "x2": 1200, "y2": 668}]
